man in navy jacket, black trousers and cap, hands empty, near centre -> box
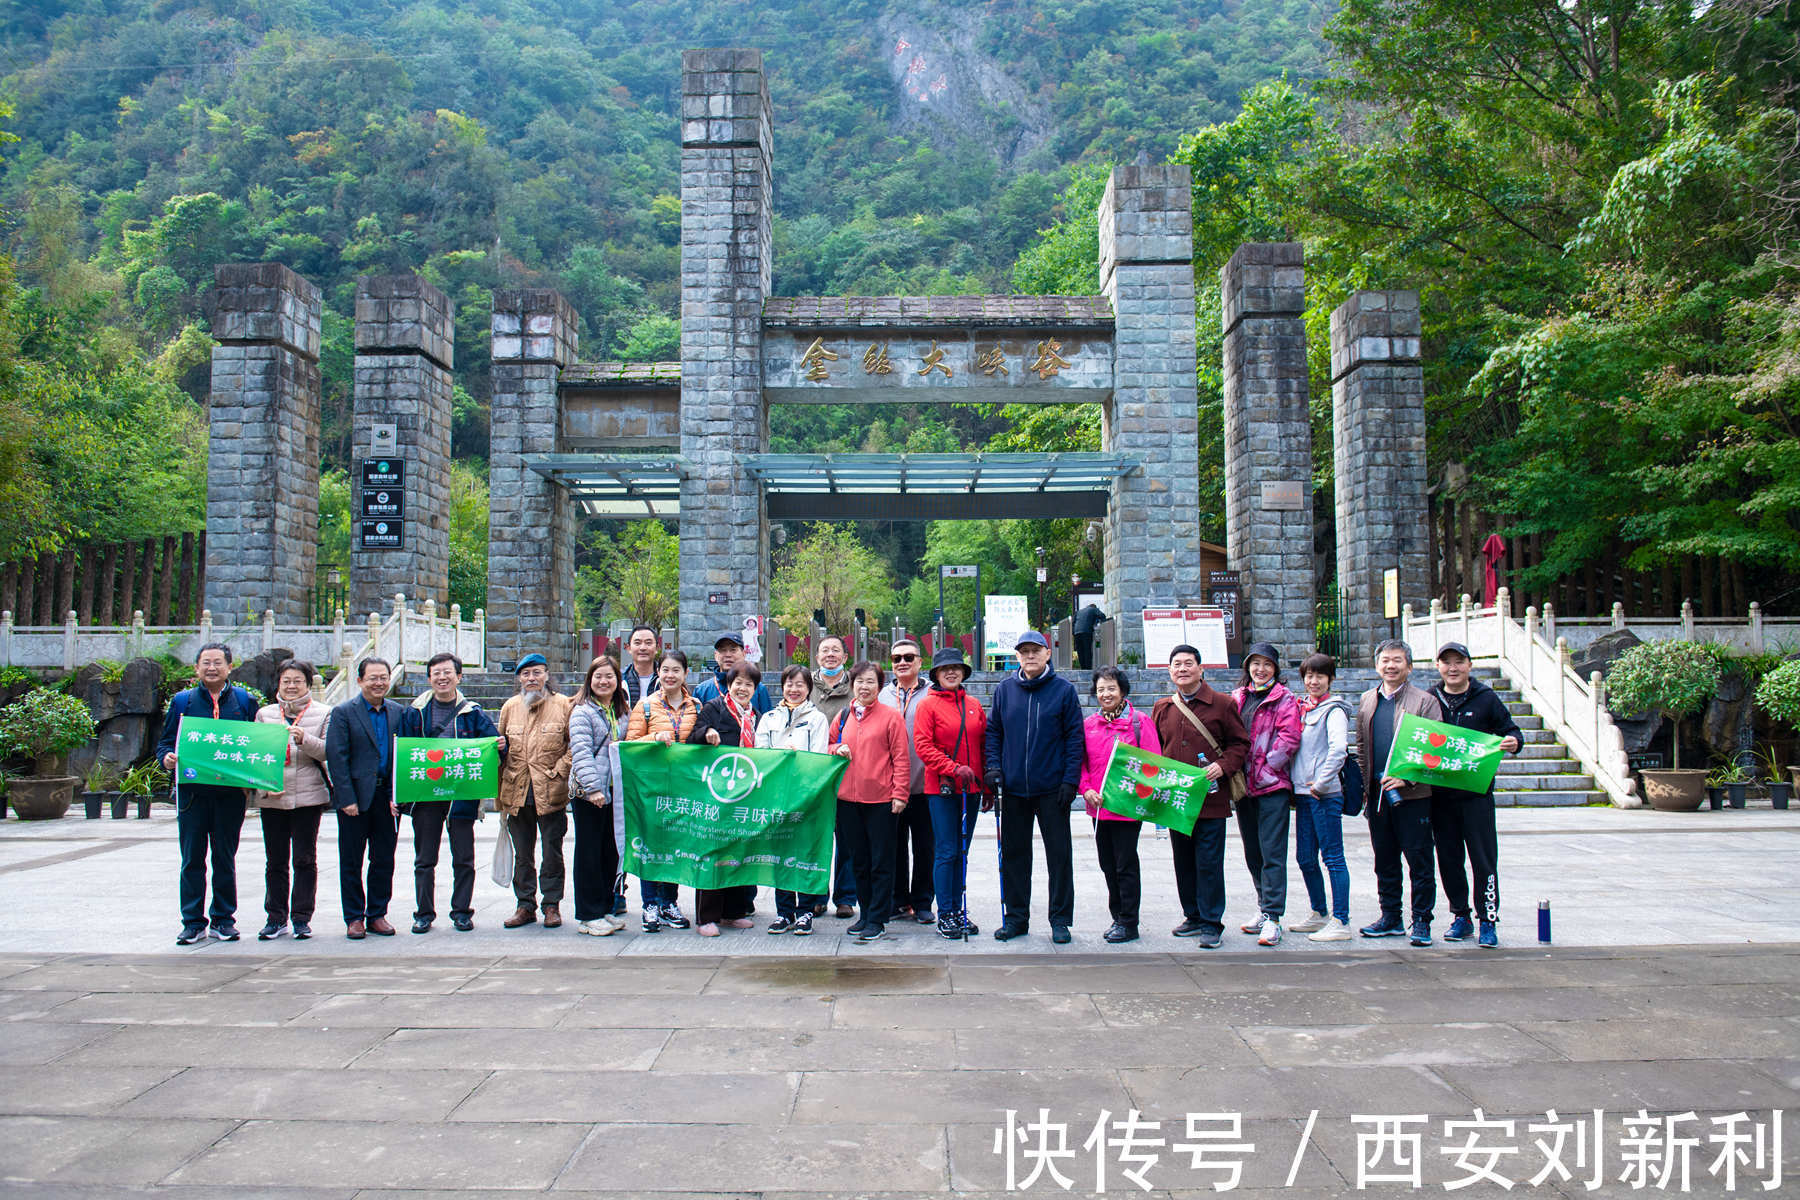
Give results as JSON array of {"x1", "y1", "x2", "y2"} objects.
[{"x1": 986, "y1": 631, "x2": 1085, "y2": 945}]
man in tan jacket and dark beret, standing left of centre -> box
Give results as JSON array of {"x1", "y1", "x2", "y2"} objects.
[{"x1": 495, "y1": 655, "x2": 574, "y2": 928}]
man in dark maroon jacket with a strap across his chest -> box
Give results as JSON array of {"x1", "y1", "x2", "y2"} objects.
[{"x1": 1150, "y1": 646, "x2": 1249, "y2": 950}]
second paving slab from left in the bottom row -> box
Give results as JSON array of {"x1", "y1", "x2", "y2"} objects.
[{"x1": 167, "y1": 1121, "x2": 587, "y2": 1191}]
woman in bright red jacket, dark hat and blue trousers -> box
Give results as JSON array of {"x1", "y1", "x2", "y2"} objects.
[{"x1": 913, "y1": 646, "x2": 992, "y2": 941}]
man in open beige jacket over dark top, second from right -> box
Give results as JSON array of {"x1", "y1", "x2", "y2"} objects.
[{"x1": 1355, "y1": 637, "x2": 1444, "y2": 946}]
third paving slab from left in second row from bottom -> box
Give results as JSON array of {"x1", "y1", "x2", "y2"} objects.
[{"x1": 452, "y1": 1070, "x2": 799, "y2": 1124}]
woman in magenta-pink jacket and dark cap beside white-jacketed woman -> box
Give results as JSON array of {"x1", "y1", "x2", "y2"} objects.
[{"x1": 1231, "y1": 642, "x2": 1303, "y2": 946}]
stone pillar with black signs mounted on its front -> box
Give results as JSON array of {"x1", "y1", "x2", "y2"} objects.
[{"x1": 349, "y1": 275, "x2": 453, "y2": 617}]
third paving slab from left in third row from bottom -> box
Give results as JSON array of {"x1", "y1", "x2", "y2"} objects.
[{"x1": 356, "y1": 1029, "x2": 670, "y2": 1070}]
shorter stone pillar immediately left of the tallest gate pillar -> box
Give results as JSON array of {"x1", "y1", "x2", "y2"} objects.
[{"x1": 488, "y1": 288, "x2": 587, "y2": 680}]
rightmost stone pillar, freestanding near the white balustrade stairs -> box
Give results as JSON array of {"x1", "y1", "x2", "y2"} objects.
[{"x1": 1332, "y1": 291, "x2": 1436, "y2": 664}]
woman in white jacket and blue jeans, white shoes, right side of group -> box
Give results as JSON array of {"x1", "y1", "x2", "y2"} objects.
[{"x1": 1289, "y1": 655, "x2": 1350, "y2": 941}]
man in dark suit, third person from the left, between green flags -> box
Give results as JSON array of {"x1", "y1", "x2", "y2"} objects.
[{"x1": 326, "y1": 658, "x2": 405, "y2": 941}]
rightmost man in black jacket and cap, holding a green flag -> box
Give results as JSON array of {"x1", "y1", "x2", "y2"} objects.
[{"x1": 1431, "y1": 642, "x2": 1525, "y2": 950}]
